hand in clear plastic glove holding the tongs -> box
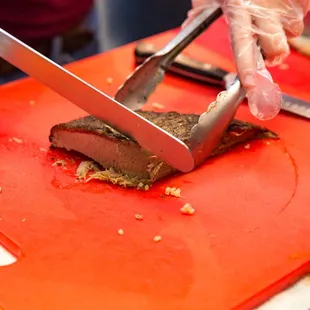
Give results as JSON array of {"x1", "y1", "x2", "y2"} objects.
[{"x1": 183, "y1": 0, "x2": 310, "y2": 120}]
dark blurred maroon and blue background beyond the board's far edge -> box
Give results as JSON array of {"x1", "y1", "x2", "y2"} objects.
[{"x1": 0, "y1": 0, "x2": 191, "y2": 84}]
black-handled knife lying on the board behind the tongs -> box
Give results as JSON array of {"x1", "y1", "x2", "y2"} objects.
[{"x1": 134, "y1": 42, "x2": 310, "y2": 119}]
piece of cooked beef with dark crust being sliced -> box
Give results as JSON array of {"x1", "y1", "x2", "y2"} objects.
[{"x1": 50, "y1": 111, "x2": 277, "y2": 187}]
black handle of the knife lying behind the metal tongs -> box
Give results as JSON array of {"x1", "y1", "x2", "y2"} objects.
[{"x1": 134, "y1": 42, "x2": 229, "y2": 88}]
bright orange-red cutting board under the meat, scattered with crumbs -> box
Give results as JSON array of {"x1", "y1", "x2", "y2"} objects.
[{"x1": 0, "y1": 21, "x2": 310, "y2": 310}]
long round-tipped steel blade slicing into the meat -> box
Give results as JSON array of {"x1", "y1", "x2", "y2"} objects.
[{"x1": 0, "y1": 28, "x2": 194, "y2": 172}]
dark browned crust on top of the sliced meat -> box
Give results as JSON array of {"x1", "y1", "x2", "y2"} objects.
[{"x1": 49, "y1": 111, "x2": 276, "y2": 148}]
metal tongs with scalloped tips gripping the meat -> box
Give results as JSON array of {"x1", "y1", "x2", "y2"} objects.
[{"x1": 114, "y1": 7, "x2": 246, "y2": 166}]
